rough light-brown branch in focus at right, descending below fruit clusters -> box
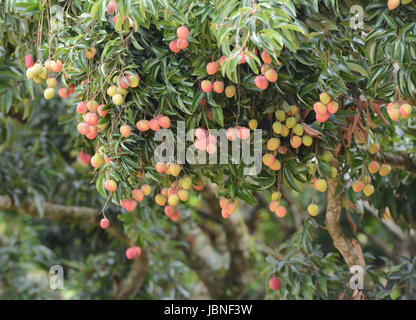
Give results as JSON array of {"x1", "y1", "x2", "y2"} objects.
[{"x1": 325, "y1": 178, "x2": 358, "y2": 267}]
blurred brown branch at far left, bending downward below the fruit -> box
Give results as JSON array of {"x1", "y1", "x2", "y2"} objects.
[{"x1": 0, "y1": 195, "x2": 149, "y2": 299}]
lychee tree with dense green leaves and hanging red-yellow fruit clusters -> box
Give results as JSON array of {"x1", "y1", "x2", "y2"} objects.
[{"x1": 1, "y1": 0, "x2": 416, "y2": 297}]
